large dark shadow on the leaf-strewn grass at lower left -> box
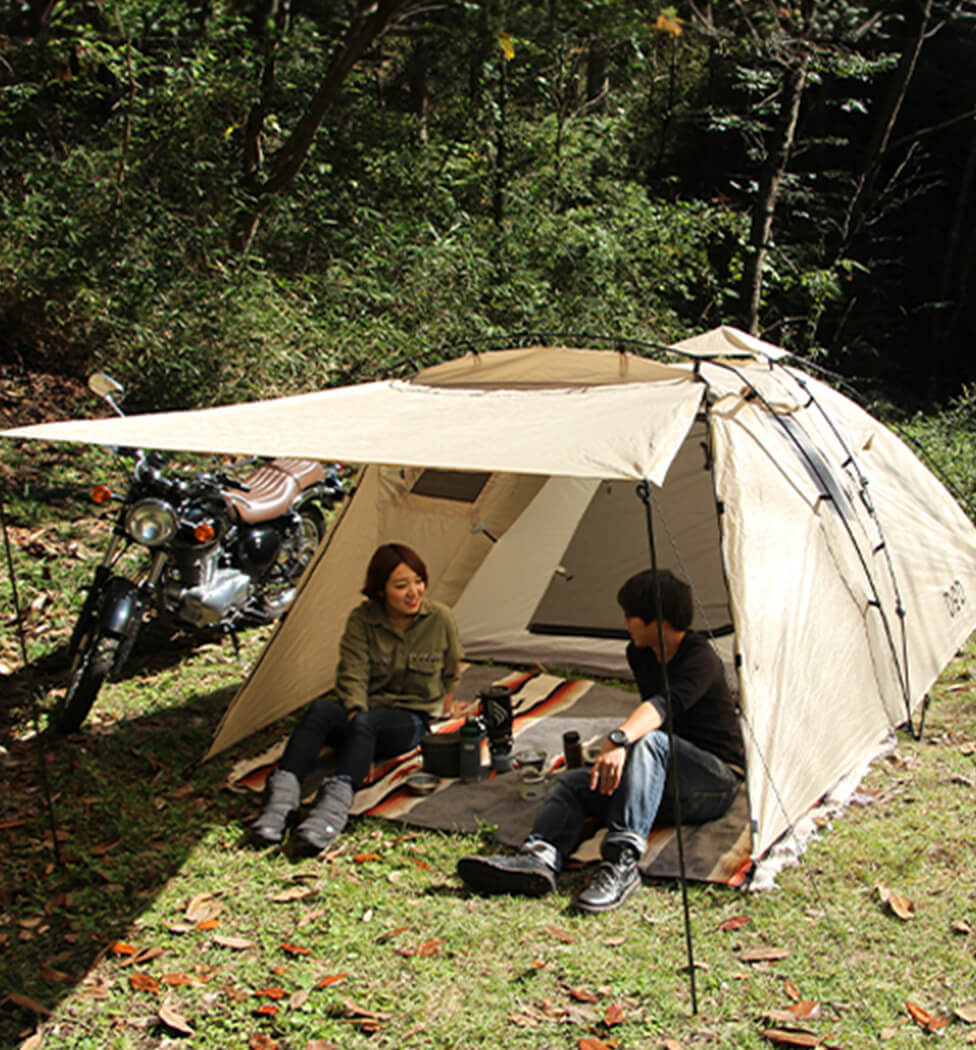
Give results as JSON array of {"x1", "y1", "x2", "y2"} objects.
[{"x1": 0, "y1": 687, "x2": 272, "y2": 1046}]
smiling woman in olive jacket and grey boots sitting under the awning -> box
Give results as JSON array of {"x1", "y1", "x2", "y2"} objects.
[{"x1": 251, "y1": 543, "x2": 464, "y2": 855}]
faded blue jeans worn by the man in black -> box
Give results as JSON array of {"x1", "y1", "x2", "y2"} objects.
[{"x1": 525, "y1": 730, "x2": 739, "y2": 870}]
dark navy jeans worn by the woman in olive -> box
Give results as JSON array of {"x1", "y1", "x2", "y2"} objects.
[{"x1": 278, "y1": 699, "x2": 429, "y2": 791}]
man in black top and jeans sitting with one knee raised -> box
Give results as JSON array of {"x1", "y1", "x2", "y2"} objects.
[{"x1": 458, "y1": 570, "x2": 743, "y2": 912}]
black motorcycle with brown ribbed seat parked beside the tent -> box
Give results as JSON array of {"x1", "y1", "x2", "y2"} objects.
[{"x1": 51, "y1": 373, "x2": 345, "y2": 733}]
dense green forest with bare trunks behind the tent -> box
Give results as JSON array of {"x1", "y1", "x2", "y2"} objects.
[{"x1": 0, "y1": 0, "x2": 976, "y2": 422}]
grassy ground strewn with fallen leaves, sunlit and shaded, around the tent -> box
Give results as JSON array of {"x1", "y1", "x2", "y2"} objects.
[{"x1": 0, "y1": 438, "x2": 976, "y2": 1050}]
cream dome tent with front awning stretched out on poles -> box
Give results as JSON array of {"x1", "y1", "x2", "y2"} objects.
[{"x1": 6, "y1": 328, "x2": 976, "y2": 857}]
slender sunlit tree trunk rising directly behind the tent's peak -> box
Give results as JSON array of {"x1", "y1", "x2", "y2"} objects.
[{"x1": 742, "y1": 58, "x2": 806, "y2": 335}]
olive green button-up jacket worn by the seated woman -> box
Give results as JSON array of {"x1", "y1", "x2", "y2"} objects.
[{"x1": 335, "y1": 597, "x2": 464, "y2": 715}]
